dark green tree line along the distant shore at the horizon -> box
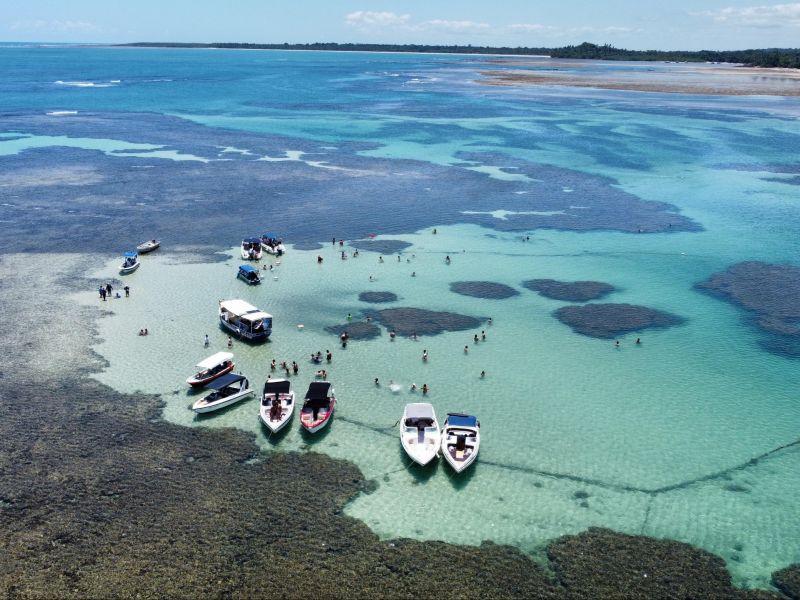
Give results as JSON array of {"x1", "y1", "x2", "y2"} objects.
[{"x1": 121, "y1": 42, "x2": 800, "y2": 69}]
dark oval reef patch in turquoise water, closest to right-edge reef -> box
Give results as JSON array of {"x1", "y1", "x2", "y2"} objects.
[{"x1": 554, "y1": 304, "x2": 684, "y2": 338}]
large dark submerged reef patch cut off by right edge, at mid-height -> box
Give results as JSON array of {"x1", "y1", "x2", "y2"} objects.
[{"x1": 695, "y1": 261, "x2": 800, "y2": 357}]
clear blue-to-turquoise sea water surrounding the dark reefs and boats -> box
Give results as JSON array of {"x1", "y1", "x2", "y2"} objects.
[{"x1": 6, "y1": 48, "x2": 800, "y2": 586}]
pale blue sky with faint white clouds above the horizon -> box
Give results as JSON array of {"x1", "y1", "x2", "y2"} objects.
[{"x1": 0, "y1": 0, "x2": 800, "y2": 50}]
